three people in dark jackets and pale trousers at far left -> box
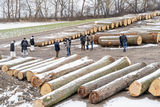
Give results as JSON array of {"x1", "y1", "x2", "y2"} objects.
[{"x1": 10, "y1": 36, "x2": 35, "y2": 58}]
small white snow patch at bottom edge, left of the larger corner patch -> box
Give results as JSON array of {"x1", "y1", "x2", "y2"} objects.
[{"x1": 56, "y1": 100, "x2": 87, "y2": 107}]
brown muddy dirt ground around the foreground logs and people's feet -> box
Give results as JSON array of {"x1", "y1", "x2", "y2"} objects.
[{"x1": 0, "y1": 17, "x2": 160, "y2": 107}]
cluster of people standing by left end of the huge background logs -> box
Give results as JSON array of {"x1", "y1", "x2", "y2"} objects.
[{"x1": 80, "y1": 35, "x2": 93, "y2": 50}]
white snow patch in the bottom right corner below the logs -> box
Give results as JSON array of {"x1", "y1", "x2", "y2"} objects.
[{"x1": 103, "y1": 97, "x2": 160, "y2": 107}]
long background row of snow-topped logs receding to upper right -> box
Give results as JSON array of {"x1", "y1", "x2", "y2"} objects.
[{"x1": 35, "y1": 11, "x2": 160, "y2": 47}]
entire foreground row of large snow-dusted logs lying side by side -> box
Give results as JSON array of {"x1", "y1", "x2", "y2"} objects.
[{"x1": 0, "y1": 54, "x2": 160, "y2": 107}]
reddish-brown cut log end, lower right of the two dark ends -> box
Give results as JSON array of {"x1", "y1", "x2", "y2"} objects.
[{"x1": 89, "y1": 91, "x2": 99, "y2": 104}]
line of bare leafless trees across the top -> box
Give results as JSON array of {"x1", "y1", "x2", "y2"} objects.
[{"x1": 0, "y1": 0, "x2": 160, "y2": 20}]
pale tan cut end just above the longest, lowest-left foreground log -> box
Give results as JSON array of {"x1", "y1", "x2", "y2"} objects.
[{"x1": 40, "y1": 83, "x2": 53, "y2": 95}]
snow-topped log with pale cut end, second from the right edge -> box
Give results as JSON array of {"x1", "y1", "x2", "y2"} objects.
[{"x1": 129, "y1": 69, "x2": 160, "y2": 97}]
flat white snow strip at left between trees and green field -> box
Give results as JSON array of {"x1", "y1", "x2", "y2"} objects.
[{"x1": 0, "y1": 21, "x2": 65, "y2": 30}]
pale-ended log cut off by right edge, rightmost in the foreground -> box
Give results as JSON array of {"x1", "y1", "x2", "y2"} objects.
[{"x1": 148, "y1": 77, "x2": 160, "y2": 97}]
